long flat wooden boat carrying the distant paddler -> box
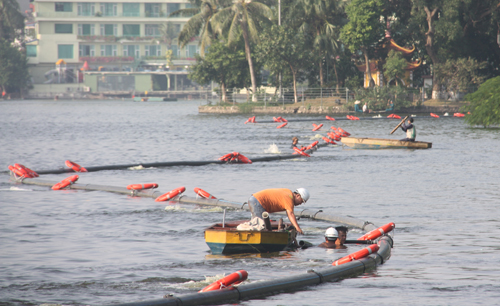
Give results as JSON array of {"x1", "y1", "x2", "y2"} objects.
[{"x1": 340, "y1": 137, "x2": 432, "y2": 149}]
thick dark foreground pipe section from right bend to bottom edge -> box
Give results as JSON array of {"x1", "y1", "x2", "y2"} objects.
[{"x1": 105, "y1": 236, "x2": 392, "y2": 306}]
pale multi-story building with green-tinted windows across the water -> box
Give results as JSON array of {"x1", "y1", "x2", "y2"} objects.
[{"x1": 27, "y1": 0, "x2": 199, "y2": 91}]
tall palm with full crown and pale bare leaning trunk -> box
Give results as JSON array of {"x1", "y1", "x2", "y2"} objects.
[{"x1": 212, "y1": 0, "x2": 272, "y2": 102}]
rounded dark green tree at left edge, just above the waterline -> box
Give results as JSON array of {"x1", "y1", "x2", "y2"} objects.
[{"x1": 0, "y1": 40, "x2": 30, "y2": 92}]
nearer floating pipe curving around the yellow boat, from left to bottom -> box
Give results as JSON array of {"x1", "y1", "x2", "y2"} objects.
[{"x1": 11, "y1": 176, "x2": 394, "y2": 306}]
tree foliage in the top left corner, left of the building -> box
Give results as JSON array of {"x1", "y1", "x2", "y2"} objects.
[{"x1": 0, "y1": 0, "x2": 24, "y2": 42}]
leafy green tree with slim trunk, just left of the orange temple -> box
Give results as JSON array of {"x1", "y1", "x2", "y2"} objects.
[{"x1": 340, "y1": 0, "x2": 384, "y2": 87}]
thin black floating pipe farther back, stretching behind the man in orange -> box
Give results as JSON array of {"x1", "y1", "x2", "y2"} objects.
[{"x1": 24, "y1": 143, "x2": 328, "y2": 174}]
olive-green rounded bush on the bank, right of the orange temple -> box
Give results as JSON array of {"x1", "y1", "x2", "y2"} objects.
[{"x1": 434, "y1": 58, "x2": 486, "y2": 92}]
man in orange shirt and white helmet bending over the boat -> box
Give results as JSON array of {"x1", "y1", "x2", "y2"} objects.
[{"x1": 248, "y1": 188, "x2": 309, "y2": 234}]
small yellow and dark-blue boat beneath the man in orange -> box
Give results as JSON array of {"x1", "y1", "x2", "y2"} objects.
[{"x1": 205, "y1": 220, "x2": 297, "y2": 254}]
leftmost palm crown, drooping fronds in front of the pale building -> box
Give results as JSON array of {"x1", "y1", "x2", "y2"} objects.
[{"x1": 170, "y1": 0, "x2": 231, "y2": 56}]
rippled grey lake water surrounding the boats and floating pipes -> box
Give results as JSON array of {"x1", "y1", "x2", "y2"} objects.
[{"x1": 0, "y1": 100, "x2": 500, "y2": 305}]
